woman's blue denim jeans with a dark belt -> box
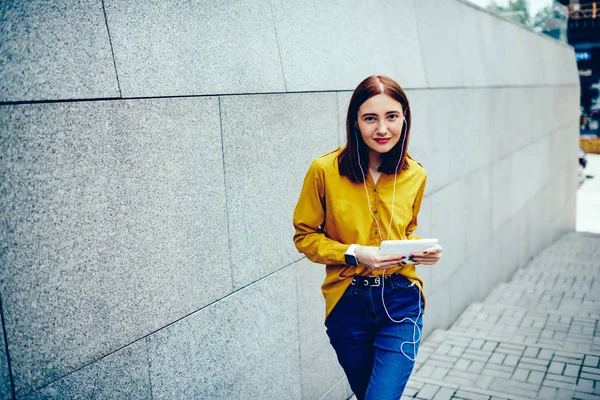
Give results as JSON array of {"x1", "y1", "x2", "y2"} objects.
[{"x1": 325, "y1": 274, "x2": 423, "y2": 400}]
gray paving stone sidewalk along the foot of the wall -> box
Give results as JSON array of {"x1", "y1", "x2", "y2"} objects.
[{"x1": 402, "y1": 232, "x2": 600, "y2": 400}]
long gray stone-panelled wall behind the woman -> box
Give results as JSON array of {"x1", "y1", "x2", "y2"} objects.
[{"x1": 0, "y1": 0, "x2": 579, "y2": 399}]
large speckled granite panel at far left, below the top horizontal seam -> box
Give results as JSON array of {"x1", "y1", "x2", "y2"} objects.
[{"x1": 0, "y1": 98, "x2": 231, "y2": 394}]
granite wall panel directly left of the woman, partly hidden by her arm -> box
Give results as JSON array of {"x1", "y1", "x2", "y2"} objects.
[{"x1": 221, "y1": 93, "x2": 338, "y2": 288}]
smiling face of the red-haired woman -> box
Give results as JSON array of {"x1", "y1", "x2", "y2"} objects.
[{"x1": 358, "y1": 93, "x2": 404, "y2": 157}]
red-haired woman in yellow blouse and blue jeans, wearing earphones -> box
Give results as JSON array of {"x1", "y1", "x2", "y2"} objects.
[{"x1": 294, "y1": 76, "x2": 442, "y2": 400}]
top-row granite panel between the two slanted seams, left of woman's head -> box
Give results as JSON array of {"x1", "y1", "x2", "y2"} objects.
[{"x1": 104, "y1": 0, "x2": 285, "y2": 97}]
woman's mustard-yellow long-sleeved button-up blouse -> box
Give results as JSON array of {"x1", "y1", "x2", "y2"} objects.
[{"x1": 294, "y1": 148, "x2": 427, "y2": 318}]
